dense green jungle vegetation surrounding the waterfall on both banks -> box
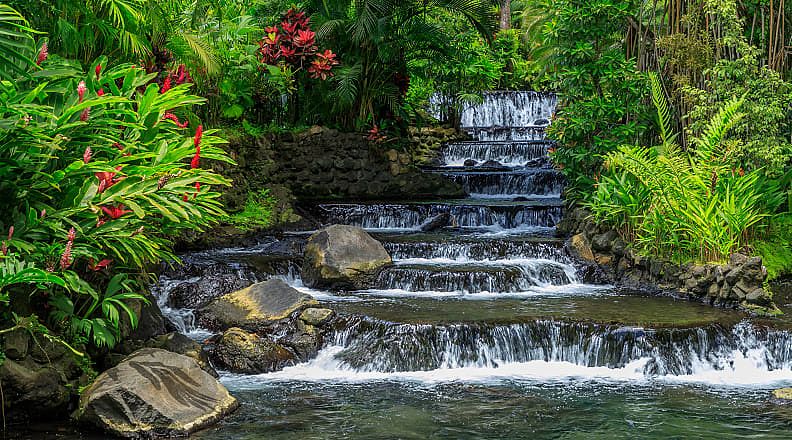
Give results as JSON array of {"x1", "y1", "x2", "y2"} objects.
[{"x1": 0, "y1": 0, "x2": 792, "y2": 360}]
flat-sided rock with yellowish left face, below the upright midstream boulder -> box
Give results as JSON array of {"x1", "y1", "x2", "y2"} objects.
[{"x1": 197, "y1": 278, "x2": 319, "y2": 331}]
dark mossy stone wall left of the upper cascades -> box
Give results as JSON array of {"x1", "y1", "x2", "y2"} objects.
[{"x1": 215, "y1": 126, "x2": 464, "y2": 209}]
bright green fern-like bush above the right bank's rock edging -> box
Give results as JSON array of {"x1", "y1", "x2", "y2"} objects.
[{"x1": 587, "y1": 77, "x2": 785, "y2": 261}]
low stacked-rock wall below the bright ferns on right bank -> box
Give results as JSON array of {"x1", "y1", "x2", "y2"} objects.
[{"x1": 557, "y1": 207, "x2": 778, "y2": 314}]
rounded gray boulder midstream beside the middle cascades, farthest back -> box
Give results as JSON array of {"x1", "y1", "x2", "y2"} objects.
[{"x1": 302, "y1": 225, "x2": 393, "y2": 289}]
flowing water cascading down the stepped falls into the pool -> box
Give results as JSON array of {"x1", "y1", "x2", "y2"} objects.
[{"x1": 153, "y1": 92, "x2": 792, "y2": 439}]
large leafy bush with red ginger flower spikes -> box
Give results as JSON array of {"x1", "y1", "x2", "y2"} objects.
[{"x1": 0, "y1": 31, "x2": 233, "y2": 347}]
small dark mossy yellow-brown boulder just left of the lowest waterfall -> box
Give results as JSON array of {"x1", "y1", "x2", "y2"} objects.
[{"x1": 211, "y1": 326, "x2": 296, "y2": 374}]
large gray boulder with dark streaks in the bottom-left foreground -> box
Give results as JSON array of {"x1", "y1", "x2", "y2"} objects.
[{"x1": 75, "y1": 348, "x2": 238, "y2": 438}]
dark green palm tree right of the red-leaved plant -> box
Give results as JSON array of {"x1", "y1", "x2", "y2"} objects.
[{"x1": 307, "y1": 0, "x2": 495, "y2": 127}]
